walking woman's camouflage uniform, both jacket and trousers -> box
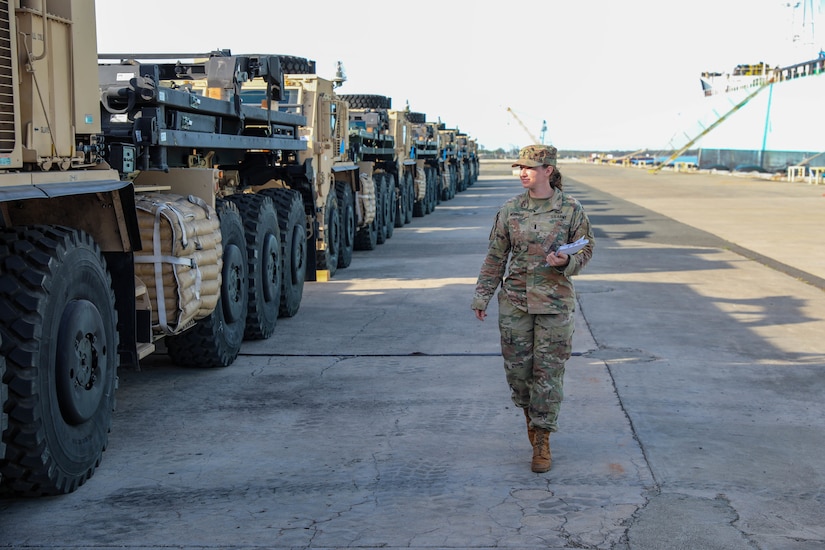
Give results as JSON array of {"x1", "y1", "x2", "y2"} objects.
[{"x1": 471, "y1": 153, "x2": 594, "y2": 432}]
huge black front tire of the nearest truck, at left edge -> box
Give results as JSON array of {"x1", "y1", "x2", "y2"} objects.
[{"x1": 0, "y1": 226, "x2": 119, "y2": 496}]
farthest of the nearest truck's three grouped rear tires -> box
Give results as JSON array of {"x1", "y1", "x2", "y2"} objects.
[{"x1": 262, "y1": 188, "x2": 308, "y2": 317}]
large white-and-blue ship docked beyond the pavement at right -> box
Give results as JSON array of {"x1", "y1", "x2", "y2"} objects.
[{"x1": 696, "y1": 0, "x2": 825, "y2": 172}]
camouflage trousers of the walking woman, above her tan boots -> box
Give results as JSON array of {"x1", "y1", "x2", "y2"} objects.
[{"x1": 498, "y1": 292, "x2": 573, "y2": 432}]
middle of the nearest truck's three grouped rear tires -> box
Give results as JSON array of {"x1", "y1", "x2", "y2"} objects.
[{"x1": 227, "y1": 193, "x2": 282, "y2": 340}]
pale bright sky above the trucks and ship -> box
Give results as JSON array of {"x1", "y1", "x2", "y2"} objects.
[{"x1": 95, "y1": 0, "x2": 821, "y2": 150}]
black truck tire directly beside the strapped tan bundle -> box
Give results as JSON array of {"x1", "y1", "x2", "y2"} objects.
[{"x1": 166, "y1": 200, "x2": 249, "y2": 368}]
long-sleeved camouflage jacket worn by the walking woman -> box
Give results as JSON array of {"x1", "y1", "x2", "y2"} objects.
[{"x1": 471, "y1": 190, "x2": 595, "y2": 314}]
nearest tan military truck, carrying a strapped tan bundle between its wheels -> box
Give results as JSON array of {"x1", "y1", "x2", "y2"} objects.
[{"x1": 0, "y1": 0, "x2": 308, "y2": 495}]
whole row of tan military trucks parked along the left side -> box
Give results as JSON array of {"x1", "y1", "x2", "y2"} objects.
[{"x1": 0, "y1": 0, "x2": 478, "y2": 496}]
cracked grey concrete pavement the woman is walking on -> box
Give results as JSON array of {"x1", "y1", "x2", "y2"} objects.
[{"x1": 0, "y1": 160, "x2": 825, "y2": 550}]
